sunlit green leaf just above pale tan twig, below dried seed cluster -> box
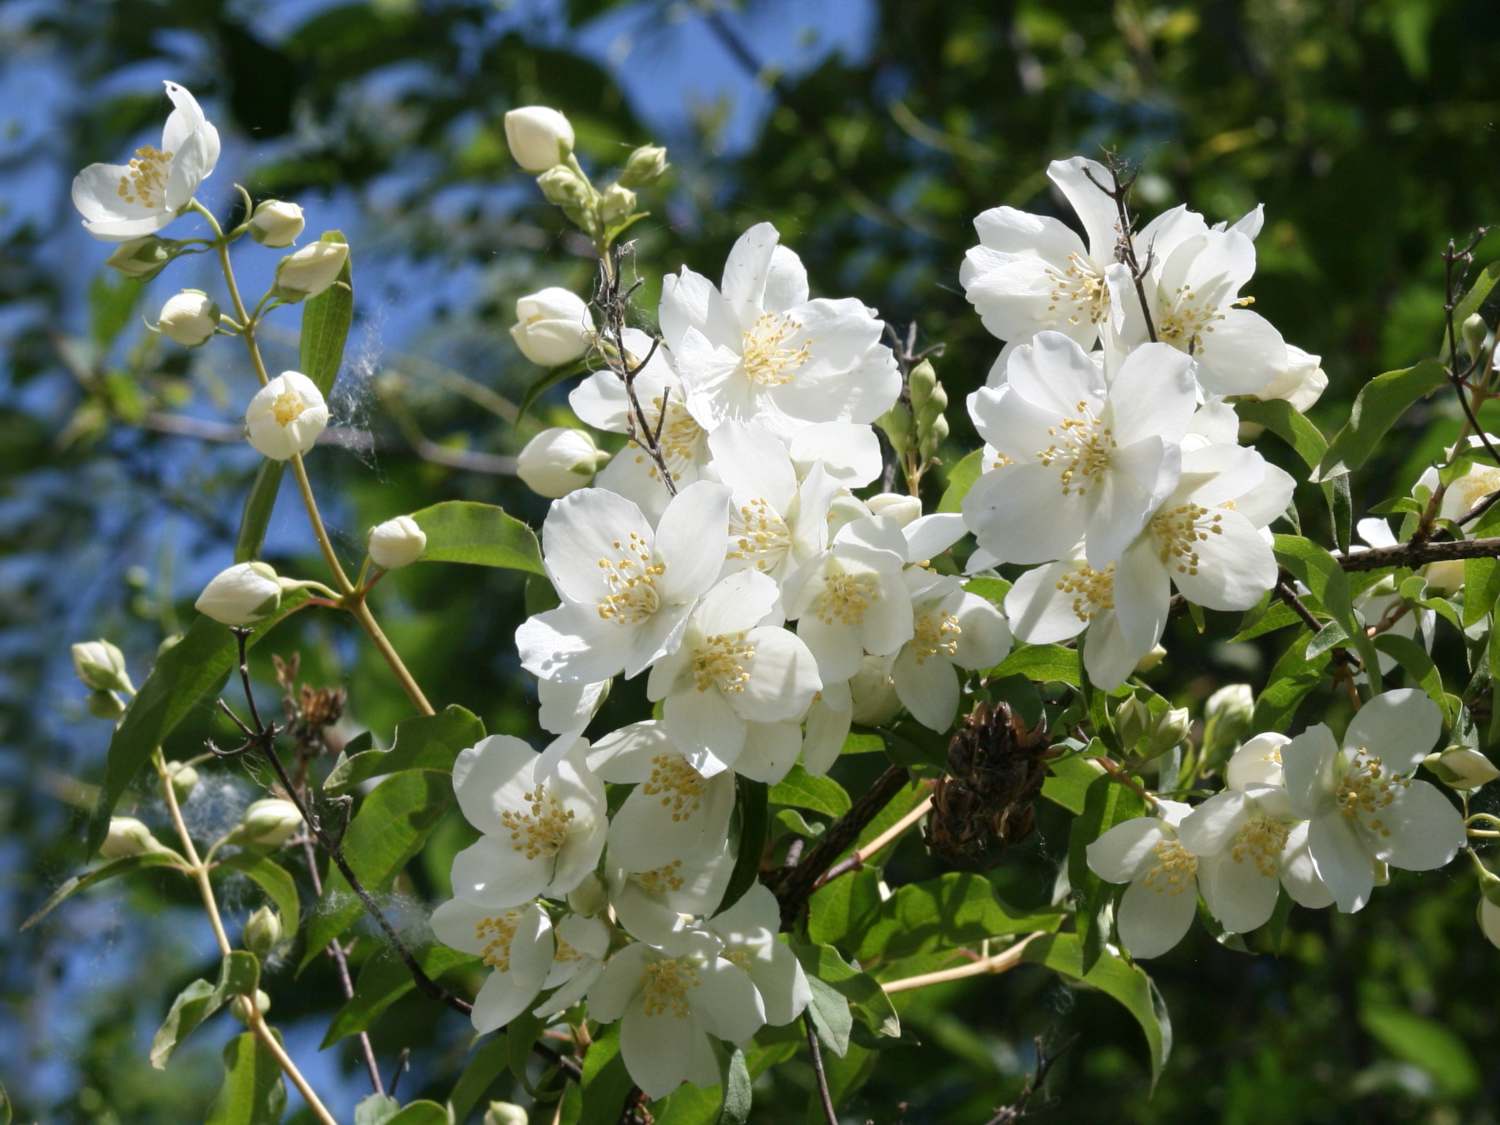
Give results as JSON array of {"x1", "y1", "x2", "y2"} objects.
[{"x1": 846, "y1": 872, "x2": 1064, "y2": 963}]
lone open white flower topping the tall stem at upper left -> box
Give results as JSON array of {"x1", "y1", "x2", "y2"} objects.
[{"x1": 74, "y1": 83, "x2": 219, "y2": 242}]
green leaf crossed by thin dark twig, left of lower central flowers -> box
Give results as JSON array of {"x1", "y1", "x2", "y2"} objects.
[{"x1": 300, "y1": 770, "x2": 453, "y2": 969}]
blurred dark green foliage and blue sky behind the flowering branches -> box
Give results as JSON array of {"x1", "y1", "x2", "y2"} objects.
[{"x1": 0, "y1": 0, "x2": 1500, "y2": 1122}]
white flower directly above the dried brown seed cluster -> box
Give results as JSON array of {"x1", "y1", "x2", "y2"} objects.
[{"x1": 891, "y1": 569, "x2": 1011, "y2": 734}]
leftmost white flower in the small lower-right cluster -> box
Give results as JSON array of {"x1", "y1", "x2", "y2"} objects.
[{"x1": 1086, "y1": 801, "x2": 1199, "y2": 957}]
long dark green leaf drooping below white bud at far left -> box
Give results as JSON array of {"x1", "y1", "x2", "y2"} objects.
[{"x1": 87, "y1": 590, "x2": 308, "y2": 855}]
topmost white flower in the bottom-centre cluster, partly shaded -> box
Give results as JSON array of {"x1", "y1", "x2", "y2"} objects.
[{"x1": 588, "y1": 720, "x2": 735, "y2": 872}]
